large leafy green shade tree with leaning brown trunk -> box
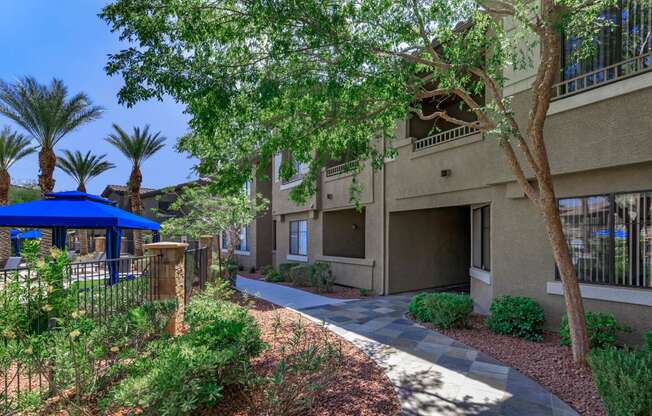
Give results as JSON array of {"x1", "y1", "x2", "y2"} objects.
[{"x1": 101, "y1": 0, "x2": 615, "y2": 362}]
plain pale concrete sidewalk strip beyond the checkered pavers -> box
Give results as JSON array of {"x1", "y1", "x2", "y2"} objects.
[{"x1": 235, "y1": 276, "x2": 348, "y2": 309}]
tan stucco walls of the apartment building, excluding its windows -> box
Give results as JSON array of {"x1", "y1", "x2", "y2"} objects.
[{"x1": 264, "y1": 73, "x2": 652, "y2": 340}]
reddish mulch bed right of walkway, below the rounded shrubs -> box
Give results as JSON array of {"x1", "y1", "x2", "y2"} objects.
[{"x1": 423, "y1": 315, "x2": 606, "y2": 416}]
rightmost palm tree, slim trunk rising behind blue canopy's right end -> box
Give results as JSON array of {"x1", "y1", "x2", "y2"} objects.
[{"x1": 106, "y1": 124, "x2": 165, "y2": 256}]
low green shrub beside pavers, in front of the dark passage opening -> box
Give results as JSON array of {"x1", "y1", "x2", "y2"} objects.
[{"x1": 408, "y1": 293, "x2": 473, "y2": 329}]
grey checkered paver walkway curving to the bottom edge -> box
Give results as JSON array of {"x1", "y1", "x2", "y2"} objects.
[{"x1": 237, "y1": 276, "x2": 577, "y2": 416}]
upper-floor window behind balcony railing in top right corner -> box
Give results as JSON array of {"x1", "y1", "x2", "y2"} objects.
[{"x1": 562, "y1": 0, "x2": 652, "y2": 86}]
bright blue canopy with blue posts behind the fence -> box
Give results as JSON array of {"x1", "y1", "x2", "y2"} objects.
[{"x1": 0, "y1": 191, "x2": 161, "y2": 283}]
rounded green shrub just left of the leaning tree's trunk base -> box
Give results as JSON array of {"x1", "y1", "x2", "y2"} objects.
[{"x1": 485, "y1": 295, "x2": 545, "y2": 341}]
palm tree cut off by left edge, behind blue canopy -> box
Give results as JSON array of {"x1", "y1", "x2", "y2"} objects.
[{"x1": 0, "y1": 127, "x2": 36, "y2": 260}]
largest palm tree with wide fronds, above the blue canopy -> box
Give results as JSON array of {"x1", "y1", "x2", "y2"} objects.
[{"x1": 0, "y1": 77, "x2": 103, "y2": 194}]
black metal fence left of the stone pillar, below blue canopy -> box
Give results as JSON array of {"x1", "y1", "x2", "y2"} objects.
[{"x1": 0, "y1": 255, "x2": 162, "y2": 414}]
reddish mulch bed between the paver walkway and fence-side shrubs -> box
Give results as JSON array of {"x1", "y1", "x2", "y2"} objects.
[{"x1": 209, "y1": 299, "x2": 400, "y2": 416}]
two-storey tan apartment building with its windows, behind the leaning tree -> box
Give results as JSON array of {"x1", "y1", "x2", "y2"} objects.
[{"x1": 272, "y1": 9, "x2": 652, "y2": 336}]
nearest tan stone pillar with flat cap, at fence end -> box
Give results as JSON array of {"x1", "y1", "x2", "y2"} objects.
[{"x1": 145, "y1": 242, "x2": 188, "y2": 335}]
